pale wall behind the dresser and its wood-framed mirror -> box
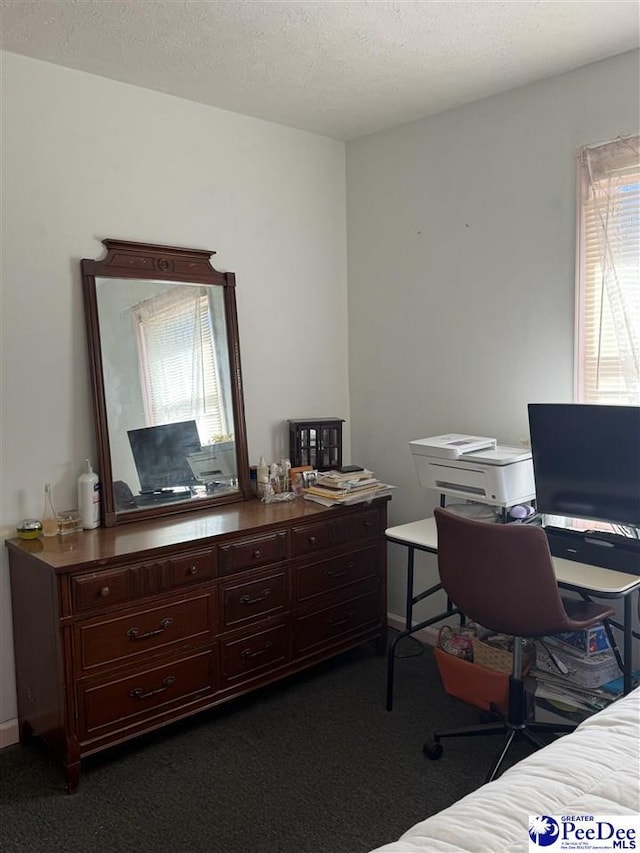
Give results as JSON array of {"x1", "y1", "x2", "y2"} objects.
[{"x1": 0, "y1": 53, "x2": 350, "y2": 732}]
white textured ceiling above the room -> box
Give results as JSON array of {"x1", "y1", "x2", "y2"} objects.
[{"x1": 0, "y1": 0, "x2": 640, "y2": 140}]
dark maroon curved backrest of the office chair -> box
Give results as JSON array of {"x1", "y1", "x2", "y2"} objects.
[{"x1": 434, "y1": 509, "x2": 569, "y2": 637}]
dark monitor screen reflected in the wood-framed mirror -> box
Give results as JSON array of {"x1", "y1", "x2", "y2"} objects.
[{"x1": 127, "y1": 421, "x2": 200, "y2": 492}]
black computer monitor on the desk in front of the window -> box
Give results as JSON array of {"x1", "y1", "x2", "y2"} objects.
[{"x1": 528, "y1": 403, "x2": 640, "y2": 527}]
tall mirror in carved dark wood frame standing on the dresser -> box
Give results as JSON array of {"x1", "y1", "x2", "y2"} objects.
[{"x1": 81, "y1": 240, "x2": 251, "y2": 527}]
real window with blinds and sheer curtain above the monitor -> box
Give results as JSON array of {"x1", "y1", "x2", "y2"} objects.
[{"x1": 576, "y1": 136, "x2": 640, "y2": 405}]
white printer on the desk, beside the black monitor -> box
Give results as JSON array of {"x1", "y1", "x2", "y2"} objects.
[{"x1": 409, "y1": 433, "x2": 535, "y2": 507}]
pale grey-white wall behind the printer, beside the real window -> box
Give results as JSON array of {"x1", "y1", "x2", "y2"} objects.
[{"x1": 347, "y1": 51, "x2": 640, "y2": 620}]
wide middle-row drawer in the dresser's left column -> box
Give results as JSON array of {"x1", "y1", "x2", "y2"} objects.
[{"x1": 73, "y1": 593, "x2": 215, "y2": 672}]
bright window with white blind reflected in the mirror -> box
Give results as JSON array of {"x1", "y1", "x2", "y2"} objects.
[{"x1": 133, "y1": 287, "x2": 227, "y2": 444}]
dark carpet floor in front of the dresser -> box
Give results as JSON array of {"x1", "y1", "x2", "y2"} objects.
[{"x1": 0, "y1": 639, "x2": 526, "y2": 853}]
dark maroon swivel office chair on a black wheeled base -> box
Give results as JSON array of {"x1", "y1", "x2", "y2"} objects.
[{"x1": 424, "y1": 509, "x2": 614, "y2": 782}]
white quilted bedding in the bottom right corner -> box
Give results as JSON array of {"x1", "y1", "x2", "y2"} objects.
[{"x1": 371, "y1": 688, "x2": 640, "y2": 853}]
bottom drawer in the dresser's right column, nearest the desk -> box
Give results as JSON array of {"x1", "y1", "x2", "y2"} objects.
[{"x1": 294, "y1": 591, "x2": 380, "y2": 655}]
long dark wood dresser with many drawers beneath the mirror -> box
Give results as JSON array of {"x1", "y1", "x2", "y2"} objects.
[{"x1": 7, "y1": 498, "x2": 388, "y2": 792}]
